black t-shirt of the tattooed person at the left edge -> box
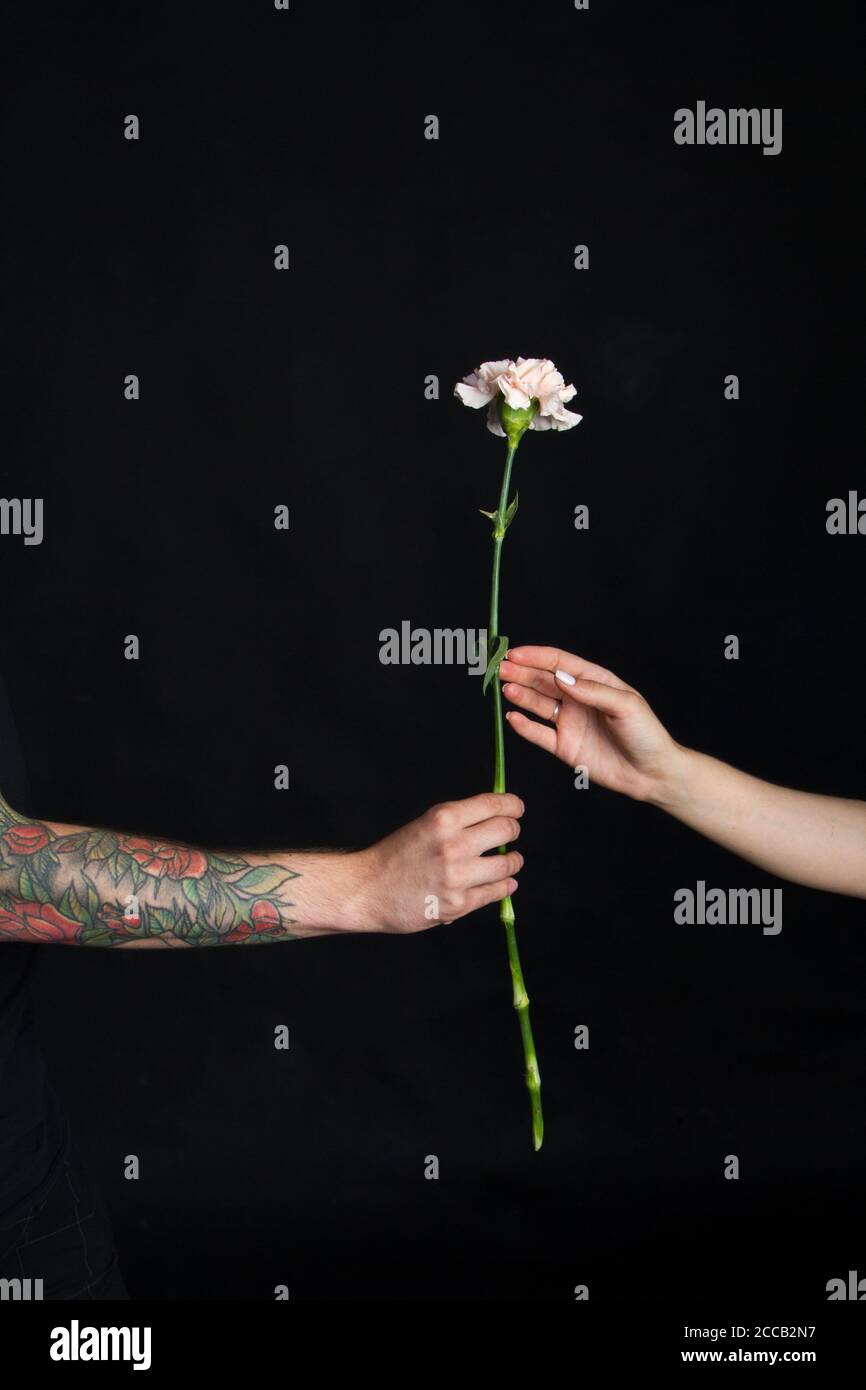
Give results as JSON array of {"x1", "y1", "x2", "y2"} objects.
[{"x1": 0, "y1": 678, "x2": 68, "y2": 1227}]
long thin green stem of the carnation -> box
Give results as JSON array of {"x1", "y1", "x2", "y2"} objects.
[{"x1": 487, "y1": 443, "x2": 545, "y2": 1151}]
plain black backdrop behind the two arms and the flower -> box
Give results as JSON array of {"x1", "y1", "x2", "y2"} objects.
[{"x1": 0, "y1": 0, "x2": 866, "y2": 1309}]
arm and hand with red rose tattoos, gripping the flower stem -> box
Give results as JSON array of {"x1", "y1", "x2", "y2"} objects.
[{"x1": 0, "y1": 792, "x2": 523, "y2": 947}]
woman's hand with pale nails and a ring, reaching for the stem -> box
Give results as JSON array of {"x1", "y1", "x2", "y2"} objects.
[{"x1": 499, "y1": 646, "x2": 685, "y2": 801}]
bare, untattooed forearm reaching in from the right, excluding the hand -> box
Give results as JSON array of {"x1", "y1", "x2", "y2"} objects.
[{"x1": 648, "y1": 746, "x2": 866, "y2": 898}]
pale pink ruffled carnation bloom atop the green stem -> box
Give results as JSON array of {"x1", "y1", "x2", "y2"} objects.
[{"x1": 455, "y1": 357, "x2": 582, "y2": 436}]
